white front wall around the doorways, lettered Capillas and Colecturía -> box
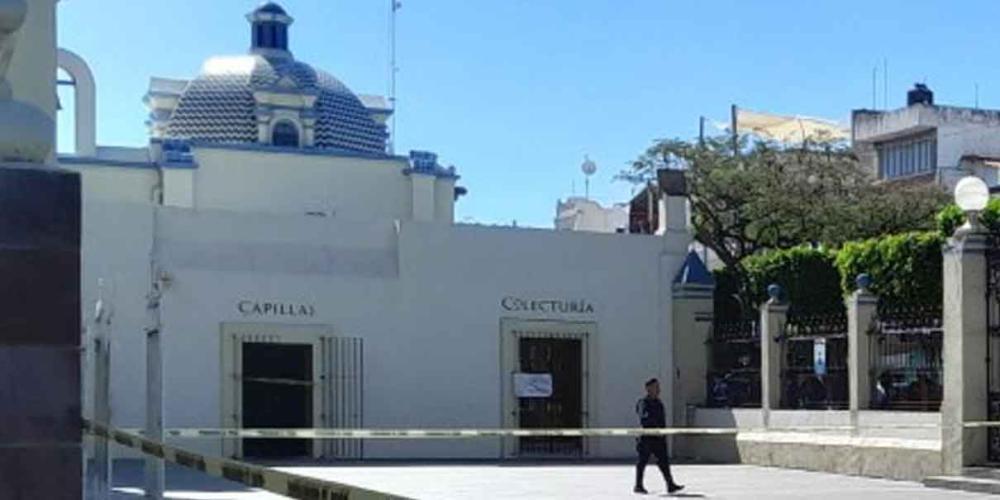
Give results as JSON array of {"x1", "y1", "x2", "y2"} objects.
[{"x1": 135, "y1": 209, "x2": 687, "y2": 458}]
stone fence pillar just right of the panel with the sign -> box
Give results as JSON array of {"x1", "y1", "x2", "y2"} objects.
[{"x1": 846, "y1": 274, "x2": 878, "y2": 428}]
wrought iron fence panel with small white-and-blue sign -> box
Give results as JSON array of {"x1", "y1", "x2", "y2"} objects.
[{"x1": 779, "y1": 312, "x2": 849, "y2": 410}]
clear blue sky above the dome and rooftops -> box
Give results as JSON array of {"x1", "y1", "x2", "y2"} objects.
[{"x1": 59, "y1": 0, "x2": 1000, "y2": 227}]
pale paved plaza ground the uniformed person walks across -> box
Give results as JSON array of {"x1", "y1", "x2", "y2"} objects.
[{"x1": 103, "y1": 463, "x2": 989, "y2": 500}]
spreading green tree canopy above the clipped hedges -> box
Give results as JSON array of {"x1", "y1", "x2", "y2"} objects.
[{"x1": 618, "y1": 138, "x2": 948, "y2": 269}]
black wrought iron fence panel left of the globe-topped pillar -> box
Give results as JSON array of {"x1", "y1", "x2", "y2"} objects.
[{"x1": 868, "y1": 305, "x2": 944, "y2": 411}]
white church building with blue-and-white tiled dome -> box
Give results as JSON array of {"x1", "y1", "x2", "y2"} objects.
[{"x1": 48, "y1": 0, "x2": 705, "y2": 459}]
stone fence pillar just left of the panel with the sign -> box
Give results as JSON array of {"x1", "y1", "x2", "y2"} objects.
[{"x1": 759, "y1": 285, "x2": 788, "y2": 427}]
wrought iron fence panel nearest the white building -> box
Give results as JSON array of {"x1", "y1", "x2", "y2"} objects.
[{"x1": 706, "y1": 319, "x2": 760, "y2": 408}]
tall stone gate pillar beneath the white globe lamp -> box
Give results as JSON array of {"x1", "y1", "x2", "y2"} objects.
[{"x1": 941, "y1": 232, "x2": 989, "y2": 475}]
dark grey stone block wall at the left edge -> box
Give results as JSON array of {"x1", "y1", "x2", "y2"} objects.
[{"x1": 0, "y1": 165, "x2": 83, "y2": 500}]
